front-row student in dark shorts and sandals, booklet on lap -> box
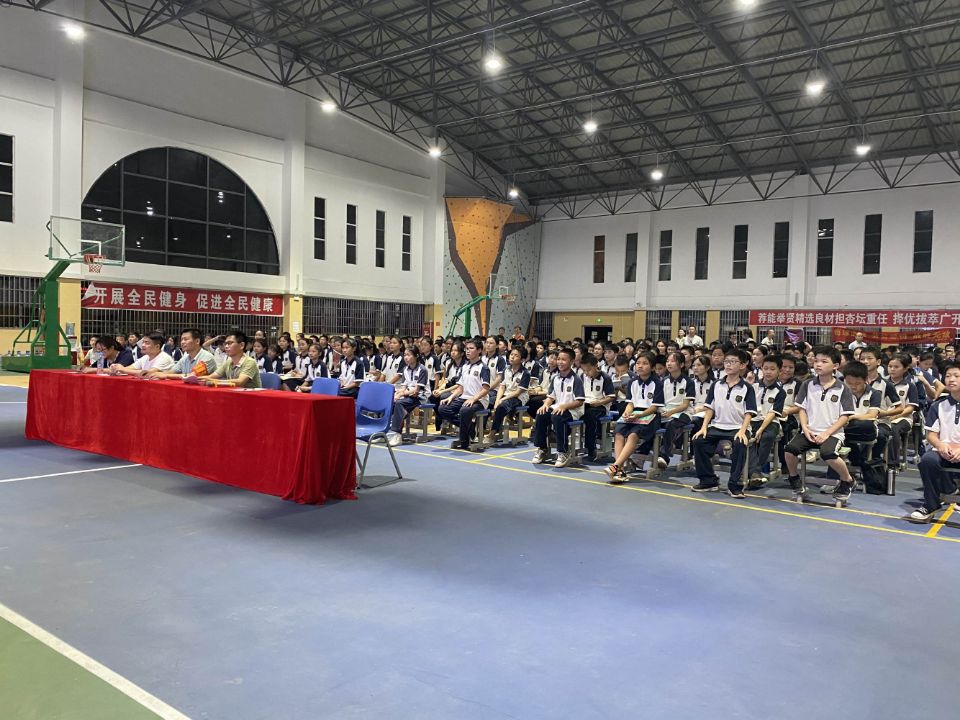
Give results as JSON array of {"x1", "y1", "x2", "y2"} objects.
[{"x1": 606, "y1": 352, "x2": 663, "y2": 484}]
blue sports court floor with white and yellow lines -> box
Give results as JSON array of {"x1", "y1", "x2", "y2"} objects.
[{"x1": 0, "y1": 387, "x2": 960, "y2": 720}]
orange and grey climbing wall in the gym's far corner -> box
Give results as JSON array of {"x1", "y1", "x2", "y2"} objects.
[{"x1": 442, "y1": 198, "x2": 540, "y2": 333}]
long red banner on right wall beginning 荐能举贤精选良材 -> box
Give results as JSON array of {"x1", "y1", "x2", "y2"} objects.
[{"x1": 749, "y1": 309, "x2": 960, "y2": 329}]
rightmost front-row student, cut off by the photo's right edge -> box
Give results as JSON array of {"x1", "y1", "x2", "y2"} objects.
[{"x1": 907, "y1": 362, "x2": 960, "y2": 523}]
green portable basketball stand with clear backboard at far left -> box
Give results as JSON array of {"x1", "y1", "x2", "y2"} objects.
[{"x1": 0, "y1": 216, "x2": 124, "y2": 373}]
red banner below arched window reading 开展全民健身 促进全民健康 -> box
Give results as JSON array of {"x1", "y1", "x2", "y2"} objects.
[{"x1": 80, "y1": 280, "x2": 283, "y2": 316}]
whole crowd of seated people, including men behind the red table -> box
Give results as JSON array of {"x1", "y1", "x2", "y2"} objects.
[{"x1": 82, "y1": 327, "x2": 960, "y2": 522}]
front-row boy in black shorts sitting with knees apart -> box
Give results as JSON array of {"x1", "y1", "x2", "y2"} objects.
[{"x1": 786, "y1": 345, "x2": 854, "y2": 502}]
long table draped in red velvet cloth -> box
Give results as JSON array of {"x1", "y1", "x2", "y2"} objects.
[{"x1": 26, "y1": 370, "x2": 357, "y2": 504}]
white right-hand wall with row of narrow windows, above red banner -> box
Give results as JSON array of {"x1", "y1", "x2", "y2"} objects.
[{"x1": 537, "y1": 158, "x2": 960, "y2": 311}]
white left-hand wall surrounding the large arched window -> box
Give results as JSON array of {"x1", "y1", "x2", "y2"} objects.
[{"x1": 0, "y1": 8, "x2": 445, "y2": 304}]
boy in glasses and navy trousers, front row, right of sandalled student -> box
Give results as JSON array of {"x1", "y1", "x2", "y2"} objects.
[{"x1": 691, "y1": 348, "x2": 757, "y2": 498}]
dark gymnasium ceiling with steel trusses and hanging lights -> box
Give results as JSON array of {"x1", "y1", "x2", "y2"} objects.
[{"x1": 7, "y1": 0, "x2": 960, "y2": 204}]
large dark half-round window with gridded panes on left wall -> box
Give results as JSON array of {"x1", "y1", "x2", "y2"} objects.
[{"x1": 81, "y1": 147, "x2": 280, "y2": 275}]
